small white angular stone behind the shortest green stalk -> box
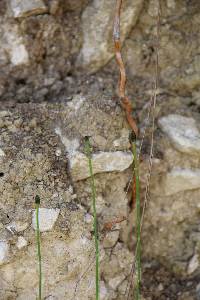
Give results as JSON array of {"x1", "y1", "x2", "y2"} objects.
[{"x1": 32, "y1": 208, "x2": 60, "y2": 232}]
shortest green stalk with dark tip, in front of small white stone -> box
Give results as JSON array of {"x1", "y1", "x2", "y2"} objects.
[{"x1": 35, "y1": 195, "x2": 42, "y2": 300}]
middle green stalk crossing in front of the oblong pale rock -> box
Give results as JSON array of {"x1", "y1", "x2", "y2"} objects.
[{"x1": 85, "y1": 137, "x2": 100, "y2": 300}]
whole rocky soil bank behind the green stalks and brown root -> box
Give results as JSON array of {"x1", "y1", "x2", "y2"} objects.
[{"x1": 0, "y1": 0, "x2": 200, "y2": 300}]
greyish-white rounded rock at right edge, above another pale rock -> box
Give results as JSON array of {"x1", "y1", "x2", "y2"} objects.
[{"x1": 158, "y1": 115, "x2": 200, "y2": 154}]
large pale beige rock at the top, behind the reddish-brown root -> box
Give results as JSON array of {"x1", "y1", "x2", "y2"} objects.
[{"x1": 77, "y1": 0, "x2": 143, "y2": 73}]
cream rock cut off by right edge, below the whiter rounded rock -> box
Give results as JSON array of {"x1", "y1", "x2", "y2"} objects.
[{"x1": 162, "y1": 168, "x2": 200, "y2": 195}]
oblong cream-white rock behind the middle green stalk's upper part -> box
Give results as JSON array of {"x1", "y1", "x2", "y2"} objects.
[{"x1": 70, "y1": 151, "x2": 133, "y2": 181}]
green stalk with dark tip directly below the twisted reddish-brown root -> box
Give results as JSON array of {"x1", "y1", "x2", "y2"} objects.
[{"x1": 132, "y1": 142, "x2": 141, "y2": 300}]
